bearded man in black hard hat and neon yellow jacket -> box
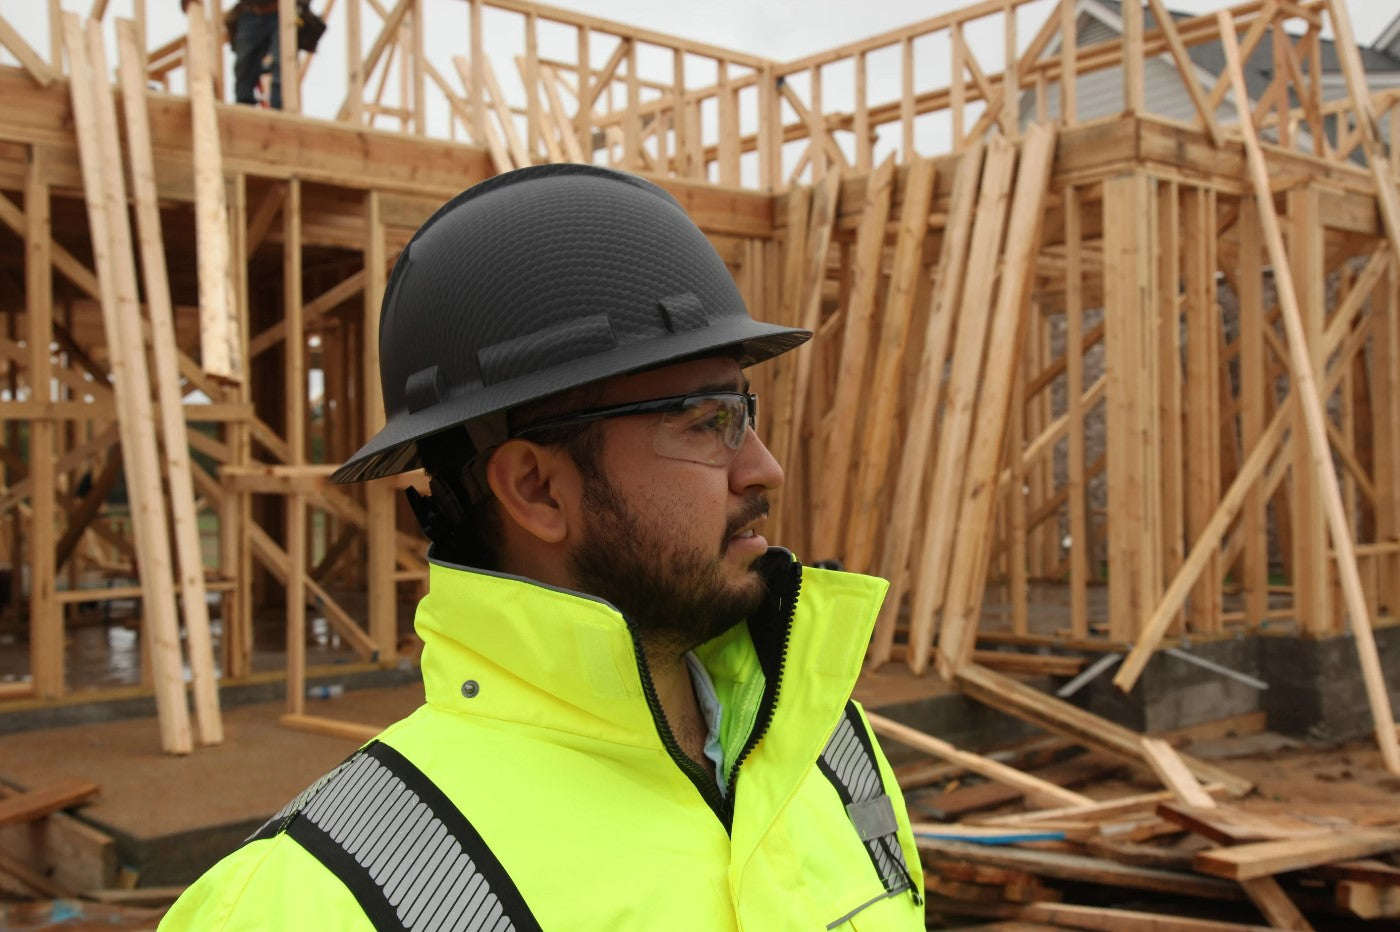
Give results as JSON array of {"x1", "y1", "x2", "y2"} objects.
[{"x1": 165, "y1": 165, "x2": 923, "y2": 932}]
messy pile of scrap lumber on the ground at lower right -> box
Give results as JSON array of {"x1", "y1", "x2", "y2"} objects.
[{"x1": 872, "y1": 663, "x2": 1400, "y2": 932}]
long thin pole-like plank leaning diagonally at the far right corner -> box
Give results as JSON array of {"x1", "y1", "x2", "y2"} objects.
[{"x1": 1217, "y1": 14, "x2": 1400, "y2": 774}]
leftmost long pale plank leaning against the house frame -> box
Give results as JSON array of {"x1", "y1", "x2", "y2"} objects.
[{"x1": 63, "y1": 13, "x2": 192, "y2": 754}]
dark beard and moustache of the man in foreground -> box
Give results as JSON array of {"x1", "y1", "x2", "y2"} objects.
[{"x1": 570, "y1": 476, "x2": 769, "y2": 656}]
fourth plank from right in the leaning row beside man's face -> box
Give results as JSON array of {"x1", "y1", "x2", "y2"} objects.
[{"x1": 843, "y1": 160, "x2": 935, "y2": 572}]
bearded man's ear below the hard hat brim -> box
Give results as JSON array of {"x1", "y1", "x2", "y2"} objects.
[{"x1": 486, "y1": 439, "x2": 580, "y2": 544}]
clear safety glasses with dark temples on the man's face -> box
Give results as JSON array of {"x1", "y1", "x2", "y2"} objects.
[{"x1": 512, "y1": 392, "x2": 759, "y2": 466}]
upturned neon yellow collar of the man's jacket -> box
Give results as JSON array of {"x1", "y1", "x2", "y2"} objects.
[{"x1": 416, "y1": 549, "x2": 888, "y2": 757}]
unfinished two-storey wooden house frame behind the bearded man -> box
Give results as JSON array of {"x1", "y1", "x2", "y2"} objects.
[{"x1": 0, "y1": 0, "x2": 1400, "y2": 767}]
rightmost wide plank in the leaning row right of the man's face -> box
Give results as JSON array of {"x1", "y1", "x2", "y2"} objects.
[{"x1": 935, "y1": 123, "x2": 1056, "y2": 679}]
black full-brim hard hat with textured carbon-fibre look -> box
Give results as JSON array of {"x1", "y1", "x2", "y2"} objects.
[{"x1": 333, "y1": 164, "x2": 812, "y2": 483}]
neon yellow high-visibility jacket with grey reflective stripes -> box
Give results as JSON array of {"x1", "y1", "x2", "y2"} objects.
[{"x1": 161, "y1": 549, "x2": 924, "y2": 932}]
